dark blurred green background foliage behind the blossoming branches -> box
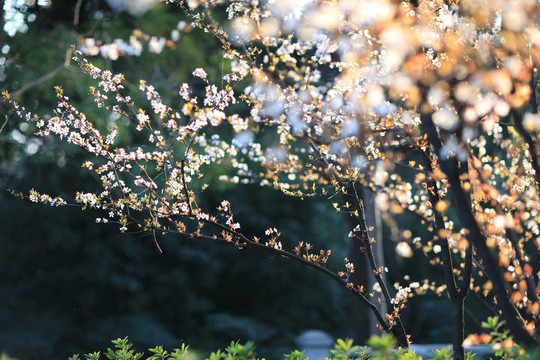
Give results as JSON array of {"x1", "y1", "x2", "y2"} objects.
[{"x1": 0, "y1": 0, "x2": 490, "y2": 360}]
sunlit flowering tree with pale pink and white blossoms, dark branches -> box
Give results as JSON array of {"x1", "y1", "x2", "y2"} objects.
[{"x1": 5, "y1": 0, "x2": 540, "y2": 359}]
